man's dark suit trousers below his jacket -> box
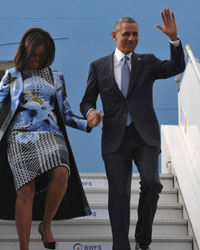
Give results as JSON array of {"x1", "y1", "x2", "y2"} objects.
[{"x1": 103, "y1": 123, "x2": 162, "y2": 250}]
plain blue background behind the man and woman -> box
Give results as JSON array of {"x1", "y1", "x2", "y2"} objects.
[{"x1": 0, "y1": 0, "x2": 200, "y2": 173}]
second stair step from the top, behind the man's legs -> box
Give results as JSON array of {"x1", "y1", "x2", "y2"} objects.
[{"x1": 84, "y1": 188, "x2": 178, "y2": 204}]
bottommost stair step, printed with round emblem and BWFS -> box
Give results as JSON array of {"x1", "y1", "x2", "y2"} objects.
[{"x1": 0, "y1": 235, "x2": 192, "y2": 250}]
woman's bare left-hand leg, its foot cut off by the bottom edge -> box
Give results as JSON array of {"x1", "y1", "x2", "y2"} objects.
[{"x1": 15, "y1": 180, "x2": 35, "y2": 250}]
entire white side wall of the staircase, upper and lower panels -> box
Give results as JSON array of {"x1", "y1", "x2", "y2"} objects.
[{"x1": 161, "y1": 45, "x2": 200, "y2": 248}]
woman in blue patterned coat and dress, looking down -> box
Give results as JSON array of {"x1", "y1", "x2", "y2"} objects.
[{"x1": 0, "y1": 28, "x2": 91, "y2": 250}]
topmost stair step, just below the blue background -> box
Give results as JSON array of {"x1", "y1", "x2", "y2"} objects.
[{"x1": 81, "y1": 173, "x2": 174, "y2": 188}]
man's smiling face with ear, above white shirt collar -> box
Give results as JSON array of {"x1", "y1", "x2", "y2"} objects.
[{"x1": 112, "y1": 23, "x2": 138, "y2": 54}]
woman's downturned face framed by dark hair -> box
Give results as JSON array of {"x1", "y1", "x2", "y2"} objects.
[{"x1": 27, "y1": 44, "x2": 46, "y2": 69}]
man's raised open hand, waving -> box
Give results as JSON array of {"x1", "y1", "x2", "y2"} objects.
[{"x1": 155, "y1": 8, "x2": 178, "y2": 41}]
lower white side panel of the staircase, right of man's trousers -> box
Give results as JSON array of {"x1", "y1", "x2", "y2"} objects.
[{"x1": 161, "y1": 126, "x2": 200, "y2": 245}]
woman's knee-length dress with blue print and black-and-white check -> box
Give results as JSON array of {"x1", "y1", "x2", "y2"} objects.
[{"x1": 7, "y1": 68, "x2": 69, "y2": 190}]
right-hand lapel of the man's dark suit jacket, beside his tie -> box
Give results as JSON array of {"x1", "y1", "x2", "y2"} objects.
[{"x1": 128, "y1": 53, "x2": 142, "y2": 95}]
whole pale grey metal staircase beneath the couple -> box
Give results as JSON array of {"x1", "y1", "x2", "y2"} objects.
[{"x1": 0, "y1": 174, "x2": 193, "y2": 250}]
